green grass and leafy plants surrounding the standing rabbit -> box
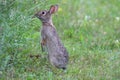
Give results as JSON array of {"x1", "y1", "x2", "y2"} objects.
[{"x1": 0, "y1": 0, "x2": 120, "y2": 80}]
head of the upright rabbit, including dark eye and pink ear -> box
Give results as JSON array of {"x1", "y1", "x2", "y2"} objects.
[{"x1": 35, "y1": 5, "x2": 58, "y2": 22}]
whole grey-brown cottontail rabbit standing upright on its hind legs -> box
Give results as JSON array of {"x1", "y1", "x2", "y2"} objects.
[{"x1": 35, "y1": 5, "x2": 68, "y2": 69}]
